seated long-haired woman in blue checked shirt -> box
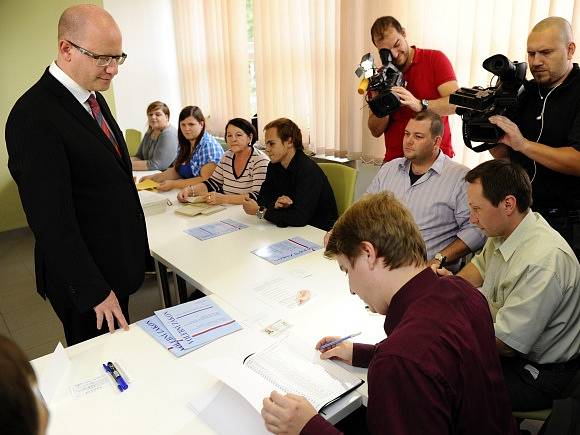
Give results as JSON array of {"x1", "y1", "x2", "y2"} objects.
[{"x1": 141, "y1": 106, "x2": 224, "y2": 191}]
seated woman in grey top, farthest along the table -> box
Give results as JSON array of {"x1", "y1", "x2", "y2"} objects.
[{"x1": 131, "y1": 101, "x2": 177, "y2": 171}]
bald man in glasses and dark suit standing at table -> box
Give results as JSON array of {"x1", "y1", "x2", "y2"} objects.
[{"x1": 6, "y1": 5, "x2": 148, "y2": 346}]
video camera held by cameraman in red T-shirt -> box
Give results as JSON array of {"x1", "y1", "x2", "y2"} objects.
[{"x1": 355, "y1": 48, "x2": 406, "y2": 118}]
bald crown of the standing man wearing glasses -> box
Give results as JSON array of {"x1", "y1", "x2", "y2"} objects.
[{"x1": 58, "y1": 5, "x2": 119, "y2": 44}]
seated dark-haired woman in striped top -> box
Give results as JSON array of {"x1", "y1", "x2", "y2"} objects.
[{"x1": 177, "y1": 118, "x2": 269, "y2": 204}]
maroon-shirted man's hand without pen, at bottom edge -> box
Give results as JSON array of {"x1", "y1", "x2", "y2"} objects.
[{"x1": 261, "y1": 391, "x2": 317, "y2": 435}]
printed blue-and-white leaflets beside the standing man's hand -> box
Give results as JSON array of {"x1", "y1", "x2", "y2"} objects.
[{"x1": 137, "y1": 296, "x2": 242, "y2": 357}]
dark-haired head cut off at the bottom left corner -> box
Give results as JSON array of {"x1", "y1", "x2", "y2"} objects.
[{"x1": 0, "y1": 335, "x2": 48, "y2": 435}]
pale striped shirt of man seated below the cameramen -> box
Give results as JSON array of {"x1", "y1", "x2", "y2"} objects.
[{"x1": 367, "y1": 152, "x2": 485, "y2": 267}]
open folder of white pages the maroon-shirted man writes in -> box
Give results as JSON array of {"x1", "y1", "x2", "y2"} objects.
[{"x1": 200, "y1": 338, "x2": 364, "y2": 413}]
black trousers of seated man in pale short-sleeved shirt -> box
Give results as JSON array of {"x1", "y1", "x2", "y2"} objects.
[{"x1": 500, "y1": 356, "x2": 580, "y2": 411}]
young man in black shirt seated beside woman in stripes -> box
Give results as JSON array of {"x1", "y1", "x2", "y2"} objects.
[{"x1": 243, "y1": 118, "x2": 338, "y2": 231}]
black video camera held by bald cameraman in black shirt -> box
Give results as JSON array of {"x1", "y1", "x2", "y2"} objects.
[{"x1": 449, "y1": 54, "x2": 528, "y2": 153}]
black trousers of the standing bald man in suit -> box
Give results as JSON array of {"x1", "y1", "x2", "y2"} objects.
[{"x1": 48, "y1": 292, "x2": 131, "y2": 346}]
